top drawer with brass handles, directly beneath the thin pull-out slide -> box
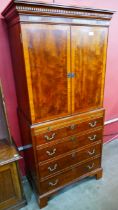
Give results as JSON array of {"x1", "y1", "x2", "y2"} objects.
[{"x1": 35, "y1": 117, "x2": 103, "y2": 146}]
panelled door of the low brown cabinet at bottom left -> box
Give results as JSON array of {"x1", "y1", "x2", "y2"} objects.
[{"x1": 0, "y1": 162, "x2": 22, "y2": 210}]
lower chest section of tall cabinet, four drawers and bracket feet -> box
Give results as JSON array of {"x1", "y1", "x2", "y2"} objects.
[{"x1": 19, "y1": 109, "x2": 104, "y2": 208}]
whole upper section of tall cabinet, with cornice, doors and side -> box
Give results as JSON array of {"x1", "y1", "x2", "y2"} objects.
[{"x1": 2, "y1": 0, "x2": 113, "y2": 123}]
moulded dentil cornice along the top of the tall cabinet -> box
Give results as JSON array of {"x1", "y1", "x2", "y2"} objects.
[{"x1": 2, "y1": 0, "x2": 114, "y2": 20}]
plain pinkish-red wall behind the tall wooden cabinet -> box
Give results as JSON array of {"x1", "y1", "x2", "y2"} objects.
[{"x1": 0, "y1": 0, "x2": 118, "y2": 174}]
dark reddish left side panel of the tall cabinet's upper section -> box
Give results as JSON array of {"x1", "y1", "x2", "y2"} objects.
[{"x1": 9, "y1": 24, "x2": 30, "y2": 120}]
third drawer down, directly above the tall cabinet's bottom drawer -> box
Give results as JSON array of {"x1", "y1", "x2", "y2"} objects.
[{"x1": 39, "y1": 144, "x2": 101, "y2": 178}]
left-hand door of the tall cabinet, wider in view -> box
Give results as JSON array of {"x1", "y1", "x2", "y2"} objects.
[{"x1": 22, "y1": 24, "x2": 71, "y2": 122}]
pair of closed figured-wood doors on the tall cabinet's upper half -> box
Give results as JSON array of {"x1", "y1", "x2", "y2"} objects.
[{"x1": 21, "y1": 24, "x2": 108, "y2": 122}]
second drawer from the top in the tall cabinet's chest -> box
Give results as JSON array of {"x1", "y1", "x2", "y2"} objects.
[{"x1": 36, "y1": 129, "x2": 102, "y2": 162}]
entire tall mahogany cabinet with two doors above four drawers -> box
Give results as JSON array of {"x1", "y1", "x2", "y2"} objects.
[{"x1": 2, "y1": 0, "x2": 113, "y2": 208}]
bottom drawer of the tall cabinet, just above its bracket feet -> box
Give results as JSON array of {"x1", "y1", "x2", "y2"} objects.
[{"x1": 40, "y1": 158, "x2": 101, "y2": 193}]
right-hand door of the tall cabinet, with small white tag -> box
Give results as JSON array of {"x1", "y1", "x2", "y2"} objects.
[{"x1": 71, "y1": 26, "x2": 108, "y2": 113}]
